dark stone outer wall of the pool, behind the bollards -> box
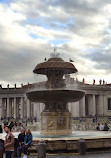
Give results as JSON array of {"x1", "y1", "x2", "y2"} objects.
[{"x1": 29, "y1": 138, "x2": 111, "y2": 153}]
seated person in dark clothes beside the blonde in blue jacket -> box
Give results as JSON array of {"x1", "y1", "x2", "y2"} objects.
[{"x1": 17, "y1": 127, "x2": 25, "y2": 158}]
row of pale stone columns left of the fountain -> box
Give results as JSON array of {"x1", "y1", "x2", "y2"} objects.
[{"x1": 0, "y1": 97, "x2": 34, "y2": 119}]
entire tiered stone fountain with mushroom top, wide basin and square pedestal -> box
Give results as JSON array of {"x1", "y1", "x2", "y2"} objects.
[{"x1": 27, "y1": 53, "x2": 84, "y2": 135}]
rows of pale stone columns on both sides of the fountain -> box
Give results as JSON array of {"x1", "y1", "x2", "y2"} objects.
[{"x1": 0, "y1": 94, "x2": 110, "y2": 119}]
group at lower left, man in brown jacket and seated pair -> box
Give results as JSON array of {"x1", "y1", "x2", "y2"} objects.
[{"x1": 0, "y1": 124, "x2": 33, "y2": 158}]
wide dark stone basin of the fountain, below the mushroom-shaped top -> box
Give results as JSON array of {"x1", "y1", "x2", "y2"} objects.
[{"x1": 26, "y1": 89, "x2": 85, "y2": 103}]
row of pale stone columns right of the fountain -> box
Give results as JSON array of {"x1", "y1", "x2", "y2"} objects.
[{"x1": 69, "y1": 94, "x2": 108, "y2": 117}]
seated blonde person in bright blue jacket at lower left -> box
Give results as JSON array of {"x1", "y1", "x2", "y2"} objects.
[{"x1": 23, "y1": 129, "x2": 33, "y2": 155}]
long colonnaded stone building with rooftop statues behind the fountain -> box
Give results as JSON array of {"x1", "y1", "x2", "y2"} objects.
[{"x1": 0, "y1": 76, "x2": 111, "y2": 119}]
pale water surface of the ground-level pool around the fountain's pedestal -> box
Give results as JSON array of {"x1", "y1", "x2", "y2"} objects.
[{"x1": 0, "y1": 131, "x2": 111, "y2": 141}]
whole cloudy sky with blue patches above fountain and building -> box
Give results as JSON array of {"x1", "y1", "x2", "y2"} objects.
[{"x1": 0, "y1": 0, "x2": 111, "y2": 87}]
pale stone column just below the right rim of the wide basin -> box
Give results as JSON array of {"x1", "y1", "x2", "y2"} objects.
[{"x1": 79, "y1": 96, "x2": 86, "y2": 116}]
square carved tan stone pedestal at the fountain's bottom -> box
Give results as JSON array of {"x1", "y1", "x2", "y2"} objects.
[{"x1": 41, "y1": 111, "x2": 72, "y2": 135}]
